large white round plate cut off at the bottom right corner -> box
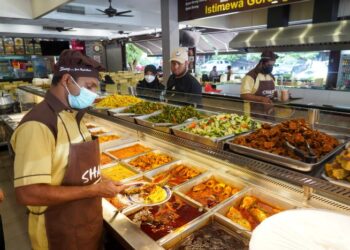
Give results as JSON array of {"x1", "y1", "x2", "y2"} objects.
[{"x1": 249, "y1": 209, "x2": 350, "y2": 250}]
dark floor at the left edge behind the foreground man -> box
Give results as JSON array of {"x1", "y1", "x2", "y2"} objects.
[{"x1": 0, "y1": 148, "x2": 31, "y2": 250}]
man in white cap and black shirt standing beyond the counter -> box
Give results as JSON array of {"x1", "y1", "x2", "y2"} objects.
[{"x1": 167, "y1": 48, "x2": 202, "y2": 103}]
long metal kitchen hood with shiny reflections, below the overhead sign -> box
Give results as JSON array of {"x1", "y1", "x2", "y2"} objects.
[{"x1": 229, "y1": 20, "x2": 350, "y2": 52}]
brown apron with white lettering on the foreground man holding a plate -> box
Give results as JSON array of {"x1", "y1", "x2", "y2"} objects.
[{"x1": 45, "y1": 115, "x2": 103, "y2": 250}]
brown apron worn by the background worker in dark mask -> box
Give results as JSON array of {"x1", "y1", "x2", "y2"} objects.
[{"x1": 250, "y1": 80, "x2": 275, "y2": 118}]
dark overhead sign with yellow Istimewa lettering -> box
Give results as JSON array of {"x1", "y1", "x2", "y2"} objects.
[{"x1": 178, "y1": 0, "x2": 305, "y2": 21}]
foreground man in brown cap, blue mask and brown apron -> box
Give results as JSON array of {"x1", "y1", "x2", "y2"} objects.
[{"x1": 11, "y1": 50, "x2": 124, "y2": 250}]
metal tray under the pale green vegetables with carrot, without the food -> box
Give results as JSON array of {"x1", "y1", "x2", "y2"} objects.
[{"x1": 171, "y1": 120, "x2": 246, "y2": 147}]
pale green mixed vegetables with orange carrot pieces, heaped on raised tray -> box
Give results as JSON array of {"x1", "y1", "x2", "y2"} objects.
[{"x1": 181, "y1": 114, "x2": 261, "y2": 139}]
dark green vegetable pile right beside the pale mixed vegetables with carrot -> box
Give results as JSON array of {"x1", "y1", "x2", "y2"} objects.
[{"x1": 148, "y1": 106, "x2": 205, "y2": 124}]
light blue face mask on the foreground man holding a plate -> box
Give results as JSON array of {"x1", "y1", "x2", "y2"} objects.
[{"x1": 65, "y1": 78, "x2": 98, "y2": 109}]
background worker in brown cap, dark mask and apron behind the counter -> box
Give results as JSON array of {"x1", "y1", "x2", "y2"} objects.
[{"x1": 241, "y1": 50, "x2": 278, "y2": 116}]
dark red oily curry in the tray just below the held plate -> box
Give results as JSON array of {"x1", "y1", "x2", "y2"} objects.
[{"x1": 129, "y1": 196, "x2": 204, "y2": 241}]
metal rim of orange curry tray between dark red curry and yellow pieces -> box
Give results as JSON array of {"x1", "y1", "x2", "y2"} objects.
[{"x1": 174, "y1": 172, "x2": 247, "y2": 210}]
